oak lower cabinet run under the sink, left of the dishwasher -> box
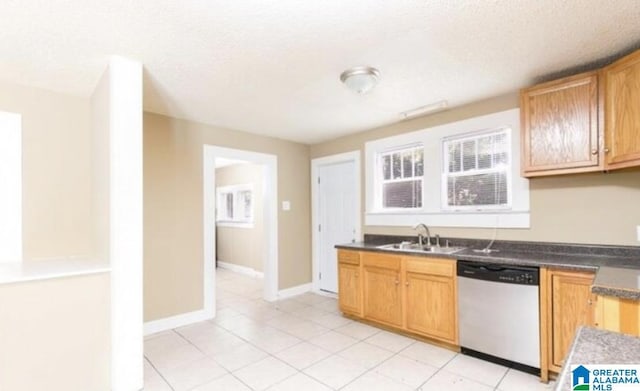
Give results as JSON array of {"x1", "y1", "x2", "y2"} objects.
[{"x1": 338, "y1": 252, "x2": 458, "y2": 345}]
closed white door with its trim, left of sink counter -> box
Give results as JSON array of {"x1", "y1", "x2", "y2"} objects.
[{"x1": 311, "y1": 151, "x2": 361, "y2": 294}]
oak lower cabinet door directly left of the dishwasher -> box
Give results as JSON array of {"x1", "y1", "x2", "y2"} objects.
[{"x1": 405, "y1": 272, "x2": 457, "y2": 344}]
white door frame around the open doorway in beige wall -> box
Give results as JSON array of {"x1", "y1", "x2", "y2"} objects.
[{"x1": 202, "y1": 144, "x2": 278, "y2": 306}]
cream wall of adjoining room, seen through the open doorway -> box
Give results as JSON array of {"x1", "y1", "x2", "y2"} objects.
[{"x1": 216, "y1": 164, "x2": 266, "y2": 272}]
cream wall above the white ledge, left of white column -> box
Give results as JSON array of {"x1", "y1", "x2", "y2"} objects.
[{"x1": 0, "y1": 82, "x2": 91, "y2": 260}]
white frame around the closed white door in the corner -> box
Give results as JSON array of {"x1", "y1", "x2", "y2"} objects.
[{"x1": 311, "y1": 150, "x2": 362, "y2": 292}]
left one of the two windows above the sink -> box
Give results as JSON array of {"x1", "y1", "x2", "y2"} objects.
[{"x1": 378, "y1": 145, "x2": 424, "y2": 209}]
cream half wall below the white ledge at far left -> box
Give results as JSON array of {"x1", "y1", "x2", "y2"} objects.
[{"x1": 0, "y1": 273, "x2": 111, "y2": 391}]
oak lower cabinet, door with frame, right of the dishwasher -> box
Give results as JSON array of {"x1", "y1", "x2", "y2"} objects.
[{"x1": 540, "y1": 268, "x2": 595, "y2": 372}]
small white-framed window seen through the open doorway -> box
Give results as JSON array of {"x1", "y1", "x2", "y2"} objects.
[{"x1": 216, "y1": 183, "x2": 255, "y2": 228}]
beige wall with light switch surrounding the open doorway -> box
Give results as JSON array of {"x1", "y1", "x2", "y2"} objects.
[{"x1": 144, "y1": 113, "x2": 311, "y2": 321}]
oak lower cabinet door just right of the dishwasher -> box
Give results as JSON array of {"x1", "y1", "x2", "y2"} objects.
[{"x1": 549, "y1": 271, "x2": 595, "y2": 371}]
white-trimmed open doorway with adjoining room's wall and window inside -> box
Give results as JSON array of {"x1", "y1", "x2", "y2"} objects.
[{"x1": 203, "y1": 145, "x2": 278, "y2": 317}]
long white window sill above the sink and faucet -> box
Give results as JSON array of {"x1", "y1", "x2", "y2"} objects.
[{"x1": 365, "y1": 211, "x2": 531, "y2": 228}]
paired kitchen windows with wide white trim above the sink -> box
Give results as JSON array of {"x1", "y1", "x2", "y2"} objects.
[{"x1": 365, "y1": 109, "x2": 530, "y2": 228}]
